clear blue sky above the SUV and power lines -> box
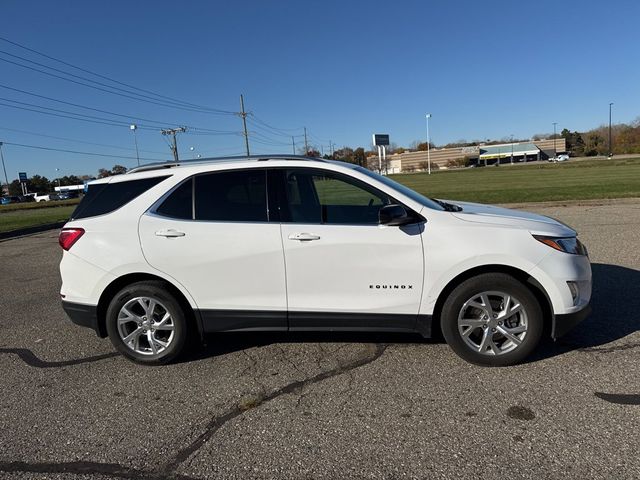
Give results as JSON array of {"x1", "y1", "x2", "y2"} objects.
[{"x1": 0, "y1": 0, "x2": 640, "y2": 181}]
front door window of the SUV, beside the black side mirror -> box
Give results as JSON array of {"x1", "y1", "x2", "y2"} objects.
[{"x1": 284, "y1": 169, "x2": 391, "y2": 225}]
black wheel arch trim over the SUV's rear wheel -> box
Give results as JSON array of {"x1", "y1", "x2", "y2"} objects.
[{"x1": 96, "y1": 272, "x2": 203, "y2": 339}]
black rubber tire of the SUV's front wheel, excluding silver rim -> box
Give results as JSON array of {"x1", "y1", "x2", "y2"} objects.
[{"x1": 440, "y1": 273, "x2": 544, "y2": 367}]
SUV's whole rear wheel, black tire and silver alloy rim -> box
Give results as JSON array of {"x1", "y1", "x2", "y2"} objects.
[{"x1": 106, "y1": 281, "x2": 188, "y2": 365}]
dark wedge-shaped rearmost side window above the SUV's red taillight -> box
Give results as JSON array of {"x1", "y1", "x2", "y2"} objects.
[{"x1": 71, "y1": 175, "x2": 169, "y2": 220}]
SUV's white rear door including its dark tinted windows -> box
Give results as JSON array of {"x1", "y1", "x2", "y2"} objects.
[{"x1": 139, "y1": 169, "x2": 287, "y2": 331}]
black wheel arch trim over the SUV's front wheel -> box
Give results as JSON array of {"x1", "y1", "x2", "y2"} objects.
[{"x1": 432, "y1": 264, "x2": 553, "y2": 338}]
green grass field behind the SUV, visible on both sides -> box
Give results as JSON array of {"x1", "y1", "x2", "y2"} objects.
[{"x1": 0, "y1": 158, "x2": 640, "y2": 232}]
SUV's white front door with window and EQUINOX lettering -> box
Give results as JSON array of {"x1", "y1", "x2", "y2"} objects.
[{"x1": 275, "y1": 168, "x2": 424, "y2": 330}]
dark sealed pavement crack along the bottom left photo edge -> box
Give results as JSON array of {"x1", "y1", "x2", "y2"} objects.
[{"x1": 0, "y1": 462, "x2": 196, "y2": 480}]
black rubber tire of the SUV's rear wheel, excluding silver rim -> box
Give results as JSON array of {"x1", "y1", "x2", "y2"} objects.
[{"x1": 106, "y1": 280, "x2": 190, "y2": 365}]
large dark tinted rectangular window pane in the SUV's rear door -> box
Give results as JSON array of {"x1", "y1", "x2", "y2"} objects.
[{"x1": 195, "y1": 169, "x2": 267, "y2": 222}]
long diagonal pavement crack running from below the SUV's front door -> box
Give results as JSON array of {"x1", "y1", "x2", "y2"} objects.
[{"x1": 163, "y1": 344, "x2": 387, "y2": 471}]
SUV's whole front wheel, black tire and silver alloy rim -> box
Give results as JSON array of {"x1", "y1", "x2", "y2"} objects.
[{"x1": 441, "y1": 273, "x2": 543, "y2": 366}]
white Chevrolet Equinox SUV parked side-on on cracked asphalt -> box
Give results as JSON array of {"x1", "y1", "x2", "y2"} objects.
[{"x1": 60, "y1": 156, "x2": 591, "y2": 366}]
